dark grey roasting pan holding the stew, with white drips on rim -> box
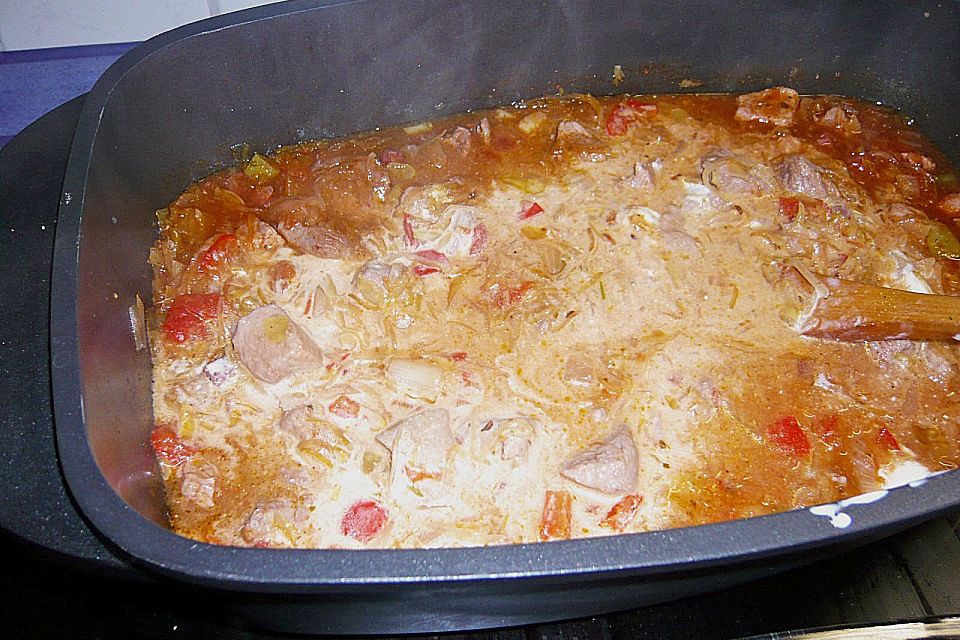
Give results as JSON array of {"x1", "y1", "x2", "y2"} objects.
[{"x1": 51, "y1": 0, "x2": 960, "y2": 632}]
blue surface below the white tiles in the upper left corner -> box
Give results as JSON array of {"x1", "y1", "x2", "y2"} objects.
[{"x1": 0, "y1": 42, "x2": 138, "y2": 146}]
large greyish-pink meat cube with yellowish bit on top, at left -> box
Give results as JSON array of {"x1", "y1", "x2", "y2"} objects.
[{"x1": 233, "y1": 305, "x2": 323, "y2": 384}]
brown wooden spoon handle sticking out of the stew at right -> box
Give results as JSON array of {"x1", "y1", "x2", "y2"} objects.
[{"x1": 798, "y1": 278, "x2": 960, "y2": 342}]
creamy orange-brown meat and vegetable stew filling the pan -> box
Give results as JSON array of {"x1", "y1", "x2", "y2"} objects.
[{"x1": 149, "y1": 88, "x2": 960, "y2": 548}]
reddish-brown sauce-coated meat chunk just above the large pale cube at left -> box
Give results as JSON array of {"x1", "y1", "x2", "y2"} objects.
[{"x1": 264, "y1": 197, "x2": 373, "y2": 259}]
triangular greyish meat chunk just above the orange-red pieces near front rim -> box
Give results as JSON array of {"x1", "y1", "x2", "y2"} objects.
[{"x1": 560, "y1": 427, "x2": 638, "y2": 494}]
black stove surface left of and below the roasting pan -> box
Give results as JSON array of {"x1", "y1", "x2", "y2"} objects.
[{"x1": 0, "y1": 82, "x2": 960, "y2": 640}]
